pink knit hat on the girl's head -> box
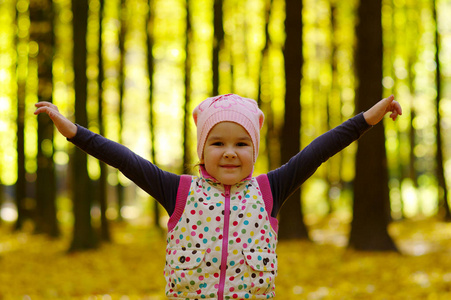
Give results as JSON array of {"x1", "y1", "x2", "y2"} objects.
[{"x1": 193, "y1": 94, "x2": 265, "y2": 163}]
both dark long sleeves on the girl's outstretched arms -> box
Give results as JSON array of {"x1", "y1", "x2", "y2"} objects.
[{"x1": 69, "y1": 113, "x2": 371, "y2": 217}]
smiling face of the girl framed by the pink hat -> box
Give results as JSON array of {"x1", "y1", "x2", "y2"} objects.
[{"x1": 201, "y1": 122, "x2": 254, "y2": 185}]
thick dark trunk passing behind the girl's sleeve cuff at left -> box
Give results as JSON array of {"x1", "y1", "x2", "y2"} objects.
[{"x1": 69, "y1": 0, "x2": 98, "y2": 251}]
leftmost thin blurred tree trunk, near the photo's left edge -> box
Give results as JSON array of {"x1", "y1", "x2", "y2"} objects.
[{"x1": 15, "y1": 3, "x2": 28, "y2": 230}]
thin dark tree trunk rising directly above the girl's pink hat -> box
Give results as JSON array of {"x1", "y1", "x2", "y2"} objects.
[{"x1": 213, "y1": 0, "x2": 224, "y2": 95}]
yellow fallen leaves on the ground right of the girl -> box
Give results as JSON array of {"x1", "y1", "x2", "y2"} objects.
[{"x1": 277, "y1": 219, "x2": 451, "y2": 299}]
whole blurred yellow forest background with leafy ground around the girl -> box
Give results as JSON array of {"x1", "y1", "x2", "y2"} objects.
[{"x1": 0, "y1": 0, "x2": 451, "y2": 299}]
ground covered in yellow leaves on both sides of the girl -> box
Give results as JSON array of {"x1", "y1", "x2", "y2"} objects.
[{"x1": 0, "y1": 218, "x2": 451, "y2": 300}]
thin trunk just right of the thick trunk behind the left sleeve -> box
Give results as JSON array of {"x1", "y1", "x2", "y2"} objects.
[{"x1": 97, "y1": 0, "x2": 111, "y2": 242}]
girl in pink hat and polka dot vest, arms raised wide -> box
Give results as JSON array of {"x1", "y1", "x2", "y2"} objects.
[{"x1": 35, "y1": 94, "x2": 402, "y2": 300}]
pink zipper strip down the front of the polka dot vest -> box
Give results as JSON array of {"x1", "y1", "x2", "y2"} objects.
[{"x1": 218, "y1": 185, "x2": 230, "y2": 300}]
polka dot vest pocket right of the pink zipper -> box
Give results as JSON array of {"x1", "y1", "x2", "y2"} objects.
[{"x1": 243, "y1": 248, "x2": 277, "y2": 295}]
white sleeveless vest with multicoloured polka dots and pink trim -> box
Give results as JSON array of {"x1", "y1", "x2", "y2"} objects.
[{"x1": 164, "y1": 176, "x2": 277, "y2": 300}]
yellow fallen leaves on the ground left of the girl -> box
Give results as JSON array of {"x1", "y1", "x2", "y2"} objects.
[{"x1": 0, "y1": 228, "x2": 165, "y2": 299}]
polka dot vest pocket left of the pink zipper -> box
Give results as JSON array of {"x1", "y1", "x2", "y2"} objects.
[{"x1": 166, "y1": 249, "x2": 205, "y2": 292}]
